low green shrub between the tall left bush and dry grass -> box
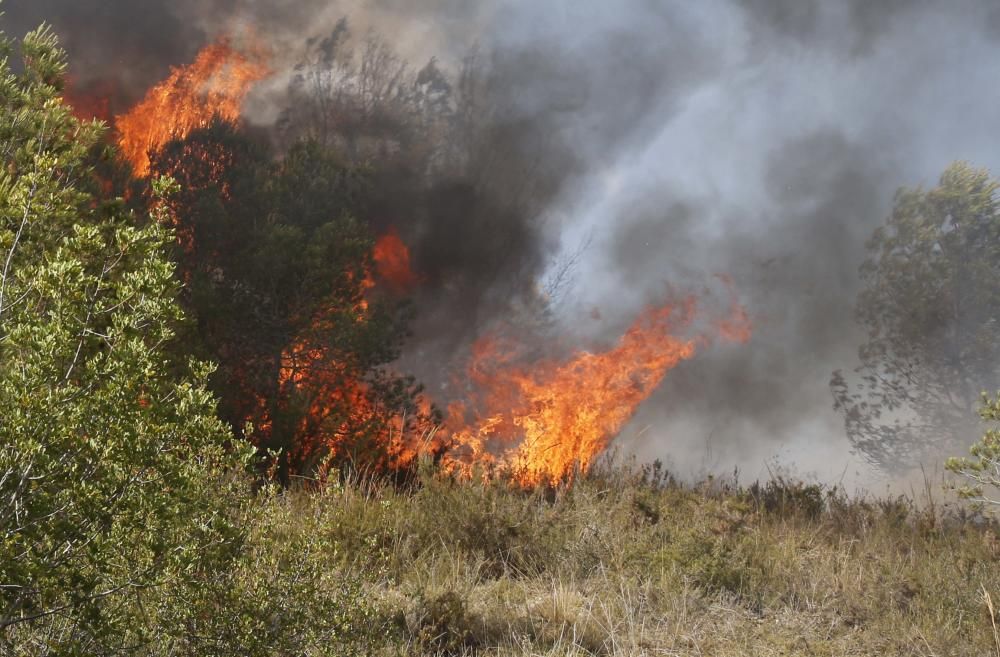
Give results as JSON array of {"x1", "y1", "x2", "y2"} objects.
[{"x1": 155, "y1": 482, "x2": 388, "y2": 657}]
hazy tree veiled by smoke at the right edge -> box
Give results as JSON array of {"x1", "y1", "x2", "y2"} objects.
[{"x1": 832, "y1": 163, "x2": 1000, "y2": 469}]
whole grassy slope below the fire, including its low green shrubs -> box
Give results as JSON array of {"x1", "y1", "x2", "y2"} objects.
[{"x1": 11, "y1": 458, "x2": 1000, "y2": 657}]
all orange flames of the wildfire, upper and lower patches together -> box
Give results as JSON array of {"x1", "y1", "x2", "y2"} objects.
[{"x1": 99, "y1": 39, "x2": 752, "y2": 486}]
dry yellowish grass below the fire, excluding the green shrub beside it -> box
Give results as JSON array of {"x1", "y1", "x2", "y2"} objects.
[{"x1": 258, "y1": 462, "x2": 1000, "y2": 656}]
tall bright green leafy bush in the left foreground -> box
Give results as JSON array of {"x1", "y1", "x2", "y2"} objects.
[{"x1": 0, "y1": 19, "x2": 248, "y2": 654}]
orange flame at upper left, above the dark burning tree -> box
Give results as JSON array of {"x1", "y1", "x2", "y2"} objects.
[{"x1": 115, "y1": 39, "x2": 270, "y2": 178}]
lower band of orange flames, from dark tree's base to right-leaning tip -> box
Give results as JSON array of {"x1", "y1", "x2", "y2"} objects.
[{"x1": 256, "y1": 232, "x2": 752, "y2": 486}]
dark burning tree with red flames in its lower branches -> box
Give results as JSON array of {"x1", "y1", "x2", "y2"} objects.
[{"x1": 151, "y1": 121, "x2": 426, "y2": 476}]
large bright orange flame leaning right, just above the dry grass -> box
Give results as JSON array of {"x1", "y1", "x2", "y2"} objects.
[{"x1": 438, "y1": 299, "x2": 701, "y2": 485}]
